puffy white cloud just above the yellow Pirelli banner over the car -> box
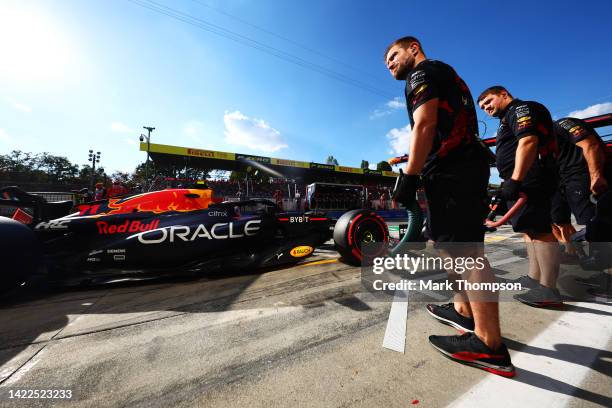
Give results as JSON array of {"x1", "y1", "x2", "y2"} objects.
[{"x1": 223, "y1": 111, "x2": 289, "y2": 153}]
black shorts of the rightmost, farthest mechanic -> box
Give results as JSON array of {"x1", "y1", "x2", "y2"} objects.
[{"x1": 551, "y1": 176, "x2": 595, "y2": 225}]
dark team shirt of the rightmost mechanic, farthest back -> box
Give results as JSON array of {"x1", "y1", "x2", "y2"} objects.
[{"x1": 555, "y1": 118, "x2": 605, "y2": 180}]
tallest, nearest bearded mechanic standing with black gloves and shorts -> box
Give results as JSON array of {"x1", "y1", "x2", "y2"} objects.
[{"x1": 385, "y1": 37, "x2": 515, "y2": 377}]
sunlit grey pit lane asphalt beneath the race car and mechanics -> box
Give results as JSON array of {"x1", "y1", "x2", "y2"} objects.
[{"x1": 0, "y1": 225, "x2": 612, "y2": 407}]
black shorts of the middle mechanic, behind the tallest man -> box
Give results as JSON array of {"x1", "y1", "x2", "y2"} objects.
[{"x1": 507, "y1": 190, "x2": 552, "y2": 234}]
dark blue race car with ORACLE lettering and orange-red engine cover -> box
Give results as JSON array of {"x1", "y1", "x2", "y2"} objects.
[{"x1": 0, "y1": 187, "x2": 331, "y2": 289}]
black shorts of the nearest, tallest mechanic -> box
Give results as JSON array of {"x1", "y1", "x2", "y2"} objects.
[{"x1": 424, "y1": 167, "x2": 489, "y2": 242}]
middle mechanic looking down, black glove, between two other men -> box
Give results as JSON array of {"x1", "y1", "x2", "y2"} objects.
[{"x1": 478, "y1": 86, "x2": 562, "y2": 307}]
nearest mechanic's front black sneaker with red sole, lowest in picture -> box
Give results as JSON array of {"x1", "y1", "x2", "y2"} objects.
[{"x1": 429, "y1": 333, "x2": 516, "y2": 377}]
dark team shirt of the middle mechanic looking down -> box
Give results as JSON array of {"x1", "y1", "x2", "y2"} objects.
[{"x1": 495, "y1": 99, "x2": 558, "y2": 187}]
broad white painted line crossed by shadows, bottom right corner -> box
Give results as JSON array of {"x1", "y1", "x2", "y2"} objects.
[{"x1": 449, "y1": 303, "x2": 612, "y2": 408}]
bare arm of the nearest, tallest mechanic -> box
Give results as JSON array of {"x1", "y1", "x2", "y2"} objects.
[{"x1": 406, "y1": 98, "x2": 438, "y2": 175}]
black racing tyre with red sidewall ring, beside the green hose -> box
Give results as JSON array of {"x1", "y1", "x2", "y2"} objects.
[{"x1": 334, "y1": 209, "x2": 389, "y2": 265}]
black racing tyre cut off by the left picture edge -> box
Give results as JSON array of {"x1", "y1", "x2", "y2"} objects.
[{"x1": 0, "y1": 217, "x2": 41, "y2": 293}]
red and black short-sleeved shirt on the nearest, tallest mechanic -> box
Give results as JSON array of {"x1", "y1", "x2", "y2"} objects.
[{"x1": 405, "y1": 60, "x2": 487, "y2": 175}]
